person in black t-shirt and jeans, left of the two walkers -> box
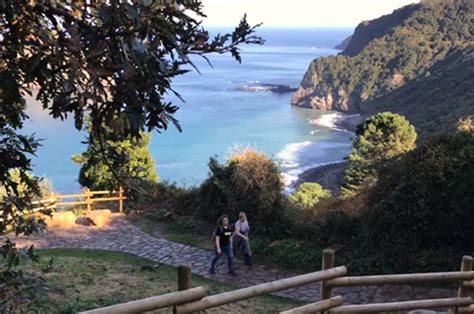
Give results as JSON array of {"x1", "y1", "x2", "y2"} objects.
[{"x1": 209, "y1": 215, "x2": 235, "y2": 275}]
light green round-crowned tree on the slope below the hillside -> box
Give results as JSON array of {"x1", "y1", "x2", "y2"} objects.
[{"x1": 342, "y1": 112, "x2": 417, "y2": 195}]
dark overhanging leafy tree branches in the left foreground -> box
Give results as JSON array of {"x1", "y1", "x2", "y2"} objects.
[{"x1": 0, "y1": 0, "x2": 263, "y2": 311}]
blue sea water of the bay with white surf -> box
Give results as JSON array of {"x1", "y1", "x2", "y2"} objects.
[{"x1": 24, "y1": 28, "x2": 352, "y2": 193}]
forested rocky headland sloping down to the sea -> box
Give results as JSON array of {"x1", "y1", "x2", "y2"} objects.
[{"x1": 292, "y1": 0, "x2": 474, "y2": 132}]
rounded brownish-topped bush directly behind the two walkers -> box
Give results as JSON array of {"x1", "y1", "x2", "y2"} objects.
[{"x1": 201, "y1": 149, "x2": 284, "y2": 232}]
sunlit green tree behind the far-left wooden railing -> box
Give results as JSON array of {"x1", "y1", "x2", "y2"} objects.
[{"x1": 72, "y1": 121, "x2": 158, "y2": 190}]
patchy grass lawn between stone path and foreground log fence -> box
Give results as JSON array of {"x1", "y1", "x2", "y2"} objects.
[{"x1": 19, "y1": 249, "x2": 302, "y2": 313}]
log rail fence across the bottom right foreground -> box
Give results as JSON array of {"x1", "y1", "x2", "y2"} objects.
[{"x1": 82, "y1": 250, "x2": 474, "y2": 314}]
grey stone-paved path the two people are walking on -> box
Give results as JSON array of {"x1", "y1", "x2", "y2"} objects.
[{"x1": 8, "y1": 215, "x2": 455, "y2": 304}]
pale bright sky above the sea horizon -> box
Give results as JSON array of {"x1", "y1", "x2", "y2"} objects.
[{"x1": 202, "y1": 0, "x2": 419, "y2": 27}]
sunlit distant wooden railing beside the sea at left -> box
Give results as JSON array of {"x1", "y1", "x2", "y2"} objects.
[{"x1": 32, "y1": 187, "x2": 127, "y2": 213}]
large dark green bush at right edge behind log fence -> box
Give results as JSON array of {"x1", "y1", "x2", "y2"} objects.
[{"x1": 363, "y1": 133, "x2": 474, "y2": 270}]
